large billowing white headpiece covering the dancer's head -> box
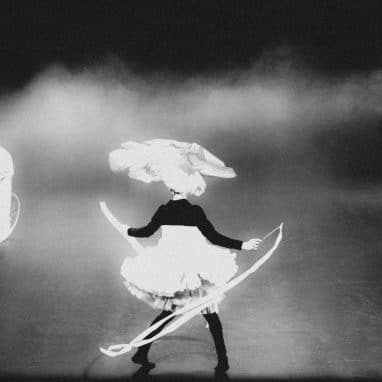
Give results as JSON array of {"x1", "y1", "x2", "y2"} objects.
[{"x1": 109, "y1": 139, "x2": 236, "y2": 196}]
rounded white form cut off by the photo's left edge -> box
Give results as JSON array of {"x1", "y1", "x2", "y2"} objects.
[{"x1": 0, "y1": 146, "x2": 14, "y2": 242}]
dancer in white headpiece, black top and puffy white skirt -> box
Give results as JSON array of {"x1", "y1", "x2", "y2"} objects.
[{"x1": 109, "y1": 140, "x2": 261, "y2": 373}]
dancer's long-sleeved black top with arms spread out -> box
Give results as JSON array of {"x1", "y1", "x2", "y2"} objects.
[{"x1": 127, "y1": 199, "x2": 243, "y2": 250}]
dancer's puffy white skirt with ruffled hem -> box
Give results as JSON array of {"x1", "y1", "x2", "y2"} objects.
[{"x1": 121, "y1": 225, "x2": 238, "y2": 313}]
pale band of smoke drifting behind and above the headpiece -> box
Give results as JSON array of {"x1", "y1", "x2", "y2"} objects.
[{"x1": 0, "y1": 52, "x2": 382, "y2": 192}]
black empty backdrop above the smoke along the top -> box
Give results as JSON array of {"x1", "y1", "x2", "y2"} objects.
[{"x1": 1, "y1": 0, "x2": 382, "y2": 83}]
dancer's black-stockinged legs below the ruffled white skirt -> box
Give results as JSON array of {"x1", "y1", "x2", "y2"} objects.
[{"x1": 138, "y1": 310, "x2": 227, "y2": 362}]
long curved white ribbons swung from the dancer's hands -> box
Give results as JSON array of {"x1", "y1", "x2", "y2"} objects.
[{"x1": 100, "y1": 202, "x2": 283, "y2": 357}]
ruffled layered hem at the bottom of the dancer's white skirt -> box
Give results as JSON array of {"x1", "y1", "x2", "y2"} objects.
[{"x1": 124, "y1": 280, "x2": 224, "y2": 314}]
